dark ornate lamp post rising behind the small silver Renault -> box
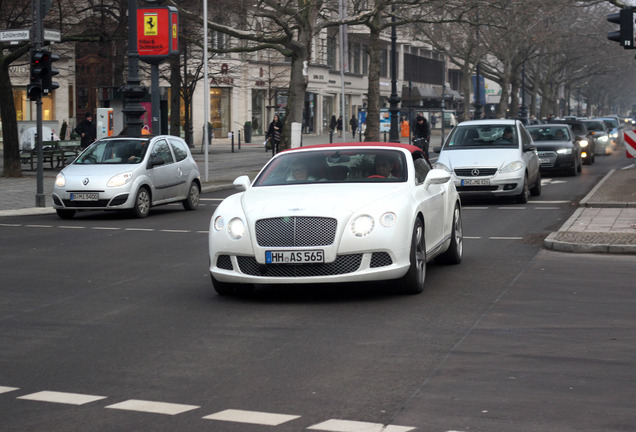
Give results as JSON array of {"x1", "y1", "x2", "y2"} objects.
[{"x1": 121, "y1": 0, "x2": 146, "y2": 136}]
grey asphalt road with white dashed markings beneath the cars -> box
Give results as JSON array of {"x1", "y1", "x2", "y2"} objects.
[{"x1": 0, "y1": 149, "x2": 636, "y2": 432}]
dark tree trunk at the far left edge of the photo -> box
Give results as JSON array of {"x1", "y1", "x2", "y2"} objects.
[{"x1": 0, "y1": 57, "x2": 22, "y2": 177}]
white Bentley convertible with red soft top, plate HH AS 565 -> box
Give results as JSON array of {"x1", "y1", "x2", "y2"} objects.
[{"x1": 209, "y1": 142, "x2": 463, "y2": 294}]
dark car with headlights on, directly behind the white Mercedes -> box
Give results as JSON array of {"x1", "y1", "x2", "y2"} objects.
[{"x1": 527, "y1": 123, "x2": 583, "y2": 176}]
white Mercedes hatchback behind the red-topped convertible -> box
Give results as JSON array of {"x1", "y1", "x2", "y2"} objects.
[{"x1": 434, "y1": 120, "x2": 541, "y2": 203}]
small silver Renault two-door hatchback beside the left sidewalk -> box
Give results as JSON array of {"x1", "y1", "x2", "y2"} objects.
[{"x1": 53, "y1": 135, "x2": 201, "y2": 219}]
